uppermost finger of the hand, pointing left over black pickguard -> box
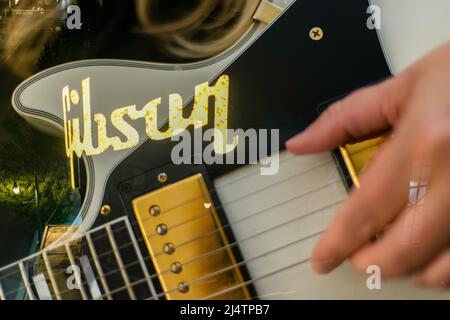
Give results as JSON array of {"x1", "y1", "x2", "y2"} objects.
[{"x1": 286, "y1": 75, "x2": 409, "y2": 154}]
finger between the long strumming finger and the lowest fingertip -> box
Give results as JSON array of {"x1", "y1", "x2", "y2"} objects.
[{"x1": 352, "y1": 171, "x2": 450, "y2": 277}]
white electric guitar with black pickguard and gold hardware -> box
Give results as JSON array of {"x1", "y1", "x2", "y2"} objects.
[{"x1": 0, "y1": 0, "x2": 449, "y2": 300}]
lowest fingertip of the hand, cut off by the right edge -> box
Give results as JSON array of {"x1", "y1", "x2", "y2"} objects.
[{"x1": 413, "y1": 248, "x2": 450, "y2": 288}]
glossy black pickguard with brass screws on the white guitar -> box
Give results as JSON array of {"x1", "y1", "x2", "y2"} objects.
[{"x1": 96, "y1": 0, "x2": 390, "y2": 298}]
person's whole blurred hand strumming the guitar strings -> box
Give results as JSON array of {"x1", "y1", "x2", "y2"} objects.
[{"x1": 287, "y1": 43, "x2": 450, "y2": 287}]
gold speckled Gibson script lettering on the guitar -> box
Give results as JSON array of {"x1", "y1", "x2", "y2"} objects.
[{"x1": 62, "y1": 75, "x2": 238, "y2": 186}]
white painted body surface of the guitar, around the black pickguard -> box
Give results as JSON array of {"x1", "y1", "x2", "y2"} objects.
[{"x1": 6, "y1": 0, "x2": 450, "y2": 299}]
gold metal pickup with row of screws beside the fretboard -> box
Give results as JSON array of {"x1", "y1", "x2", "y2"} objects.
[{"x1": 132, "y1": 174, "x2": 250, "y2": 300}]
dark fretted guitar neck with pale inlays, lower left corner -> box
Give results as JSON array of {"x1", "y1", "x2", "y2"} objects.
[{"x1": 0, "y1": 217, "x2": 155, "y2": 300}]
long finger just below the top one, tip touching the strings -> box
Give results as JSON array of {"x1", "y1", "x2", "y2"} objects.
[{"x1": 311, "y1": 134, "x2": 409, "y2": 273}]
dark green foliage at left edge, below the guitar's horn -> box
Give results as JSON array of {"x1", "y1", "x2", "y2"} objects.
[{"x1": 0, "y1": 114, "x2": 73, "y2": 224}]
